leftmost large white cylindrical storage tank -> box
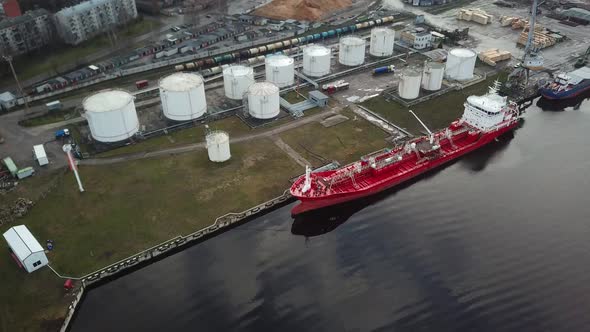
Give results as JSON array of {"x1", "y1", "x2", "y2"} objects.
[{"x1": 82, "y1": 89, "x2": 139, "y2": 143}]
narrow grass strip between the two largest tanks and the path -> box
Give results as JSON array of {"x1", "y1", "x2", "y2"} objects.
[{"x1": 98, "y1": 116, "x2": 250, "y2": 157}]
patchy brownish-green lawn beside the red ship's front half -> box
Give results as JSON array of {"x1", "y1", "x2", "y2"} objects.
[{"x1": 280, "y1": 110, "x2": 388, "y2": 167}]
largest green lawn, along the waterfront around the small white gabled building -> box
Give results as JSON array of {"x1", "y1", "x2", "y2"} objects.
[{"x1": 0, "y1": 139, "x2": 302, "y2": 331}]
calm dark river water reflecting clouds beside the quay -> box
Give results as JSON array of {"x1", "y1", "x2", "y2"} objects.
[{"x1": 71, "y1": 94, "x2": 590, "y2": 332}]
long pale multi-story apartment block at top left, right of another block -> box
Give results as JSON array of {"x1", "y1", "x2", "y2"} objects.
[{"x1": 55, "y1": 0, "x2": 137, "y2": 45}]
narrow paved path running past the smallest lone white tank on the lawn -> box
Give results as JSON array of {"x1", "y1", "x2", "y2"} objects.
[{"x1": 80, "y1": 111, "x2": 337, "y2": 165}]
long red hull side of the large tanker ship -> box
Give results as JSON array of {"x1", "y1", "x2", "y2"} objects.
[{"x1": 291, "y1": 122, "x2": 518, "y2": 215}]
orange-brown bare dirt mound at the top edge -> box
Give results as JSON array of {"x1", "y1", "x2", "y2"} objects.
[{"x1": 254, "y1": 0, "x2": 352, "y2": 21}]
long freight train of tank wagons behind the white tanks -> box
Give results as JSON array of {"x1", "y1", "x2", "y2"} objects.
[{"x1": 174, "y1": 16, "x2": 393, "y2": 76}]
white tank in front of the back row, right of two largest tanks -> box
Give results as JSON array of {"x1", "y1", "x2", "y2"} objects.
[{"x1": 248, "y1": 82, "x2": 280, "y2": 119}]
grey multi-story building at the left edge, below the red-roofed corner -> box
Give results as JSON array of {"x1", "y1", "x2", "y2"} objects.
[{"x1": 0, "y1": 9, "x2": 55, "y2": 55}]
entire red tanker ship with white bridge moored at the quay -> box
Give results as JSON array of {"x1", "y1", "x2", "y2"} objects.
[{"x1": 291, "y1": 82, "x2": 520, "y2": 215}]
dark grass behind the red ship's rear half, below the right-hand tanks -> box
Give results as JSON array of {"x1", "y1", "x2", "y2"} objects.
[{"x1": 362, "y1": 75, "x2": 504, "y2": 134}]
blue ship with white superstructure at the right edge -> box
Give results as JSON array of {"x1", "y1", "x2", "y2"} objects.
[{"x1": 540, "y1": 67, "x2": 590, "y2": 100}]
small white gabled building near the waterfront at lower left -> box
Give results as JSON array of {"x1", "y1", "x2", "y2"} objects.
[{"x1": 4, "y1": 225, "x2": 49, "y2": 273}]
